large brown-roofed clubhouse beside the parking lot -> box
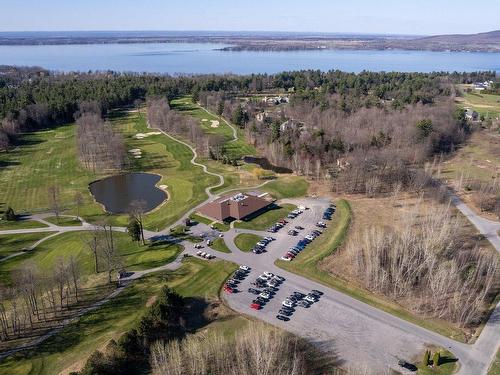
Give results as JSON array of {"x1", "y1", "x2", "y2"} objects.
[{"x1": 199, "y1": 193, "x2": 273, "y2": 221}]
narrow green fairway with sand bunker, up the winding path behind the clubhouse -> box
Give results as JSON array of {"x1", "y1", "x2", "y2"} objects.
[{"x1": 170, "y1": 96, "x2": 256, "y2": 158}]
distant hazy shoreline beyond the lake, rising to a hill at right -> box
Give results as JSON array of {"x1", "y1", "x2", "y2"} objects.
[{"x1": 0, "y1": 31, "x2": 500, "y2": 52}]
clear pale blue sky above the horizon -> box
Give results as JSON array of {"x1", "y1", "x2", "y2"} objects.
[{"x1": 0, "y1": 0, "x2": 500, "y2": 35}]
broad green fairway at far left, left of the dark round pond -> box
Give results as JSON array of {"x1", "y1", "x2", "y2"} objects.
[{"x1": 0, "y1": 124, "x2": 100, "y2": 213}]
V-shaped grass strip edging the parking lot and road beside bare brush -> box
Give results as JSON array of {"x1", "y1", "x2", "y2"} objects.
[{"x1": 276, "y1": 200, "x2": 465, "y2": 341}]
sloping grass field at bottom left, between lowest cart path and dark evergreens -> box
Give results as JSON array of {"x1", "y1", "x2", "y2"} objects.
[{"x1": 0, "y1": 258, "x2": 238, "y2": 375}]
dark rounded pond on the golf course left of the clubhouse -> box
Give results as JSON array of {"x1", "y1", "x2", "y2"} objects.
[{"x1": 89, "y1": 173, "x2": 167, "y2": 214}]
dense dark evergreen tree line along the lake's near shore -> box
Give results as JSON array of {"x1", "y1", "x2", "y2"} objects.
[{"x1": 0, "y1": 67, "x2": 494, "y2": 151}]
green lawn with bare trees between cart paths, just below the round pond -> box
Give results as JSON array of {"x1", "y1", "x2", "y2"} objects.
[{"x1": 0, "y1": 232, "x2": 182, "y2": 283}]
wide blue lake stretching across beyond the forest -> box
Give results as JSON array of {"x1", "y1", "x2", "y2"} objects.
[{"x1": 0, "y1": 43, "x2": 500, "y2": 74}]
